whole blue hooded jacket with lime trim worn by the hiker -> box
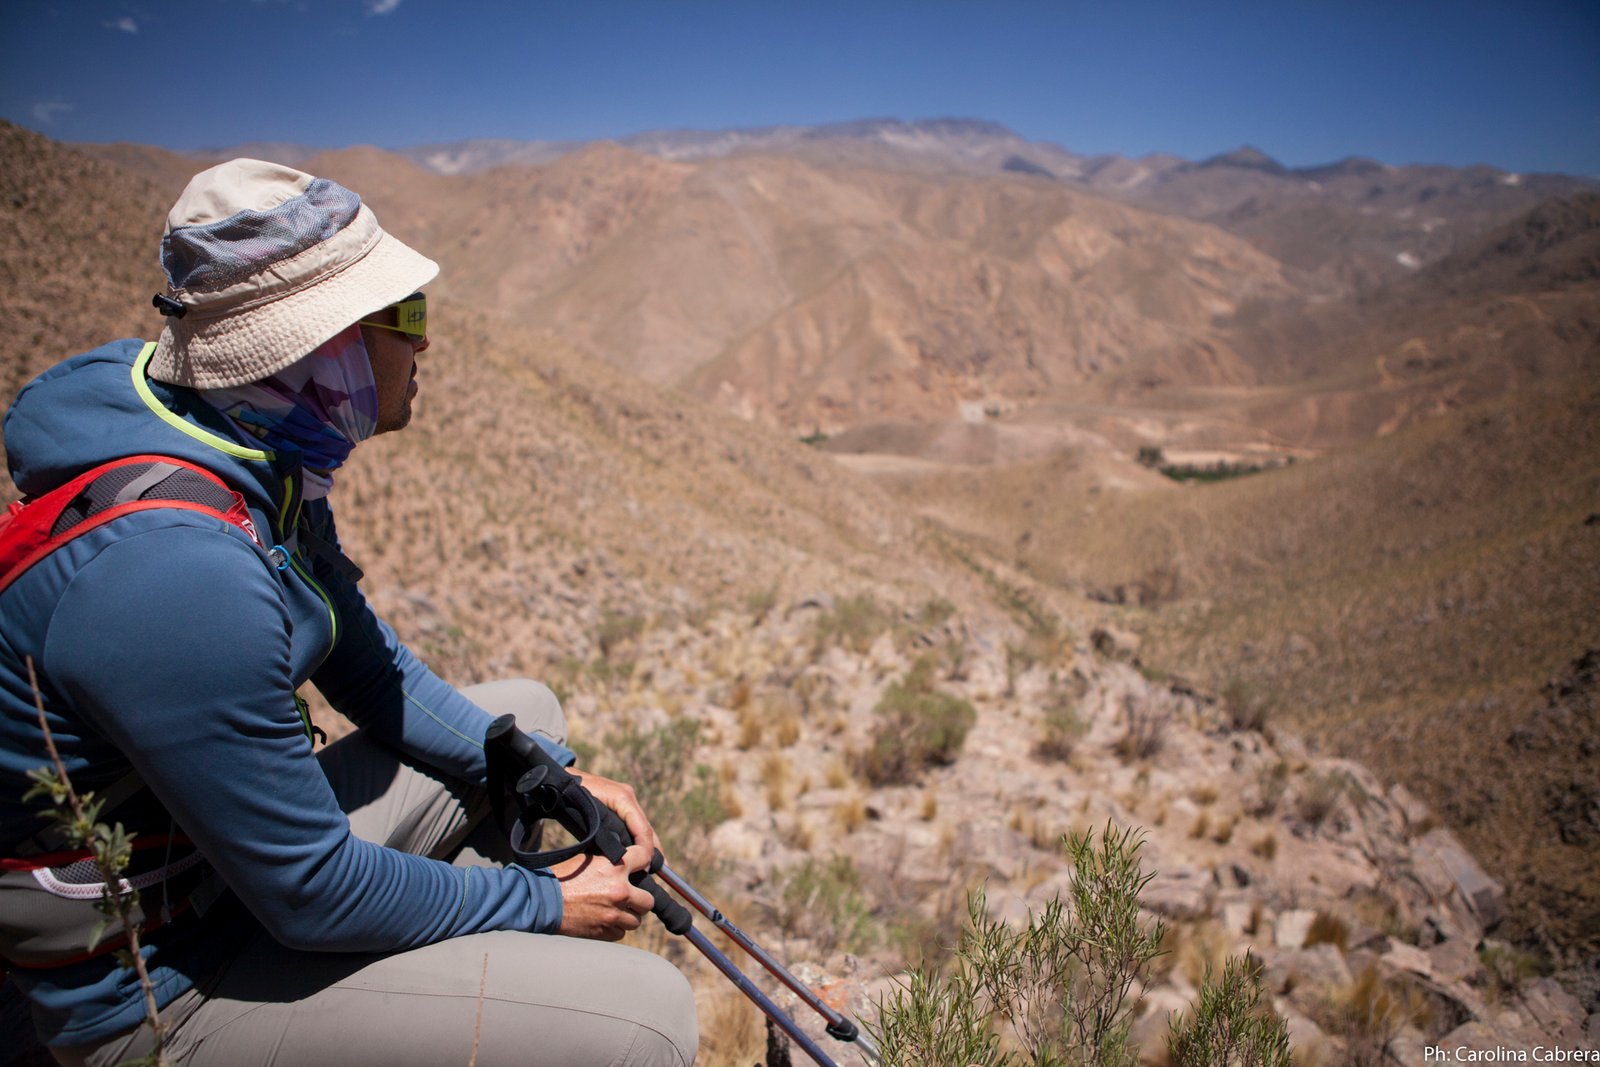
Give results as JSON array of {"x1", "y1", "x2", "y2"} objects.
[{"x1": 0, "y1": 341, "x2": 571, "y2": 1045}]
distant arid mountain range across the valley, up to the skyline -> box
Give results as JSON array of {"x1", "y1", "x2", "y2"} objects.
[{"x1": 78, "y1": 120, "x2": 1586, "y2": 450}]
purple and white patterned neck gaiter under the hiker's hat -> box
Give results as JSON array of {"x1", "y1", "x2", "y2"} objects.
[{"x1": 198, "y1": 325, "x2": 378, "y2": 501}]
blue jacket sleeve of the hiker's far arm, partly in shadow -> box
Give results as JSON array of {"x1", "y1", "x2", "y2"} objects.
[{"x1": 307, "y1": 502, "x2": 573, "y2": 784}]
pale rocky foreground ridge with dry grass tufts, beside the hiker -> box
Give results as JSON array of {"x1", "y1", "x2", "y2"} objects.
[{"x1": 489, "y1": 595, "x2": 1600, "y2": 1064}]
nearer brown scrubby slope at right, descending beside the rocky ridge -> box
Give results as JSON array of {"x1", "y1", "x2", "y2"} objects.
[{"x1": 890, "y1": 374, "x2": 1600, "y2": 952}]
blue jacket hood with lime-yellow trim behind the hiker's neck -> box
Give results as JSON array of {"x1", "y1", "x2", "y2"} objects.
[{"x1": 5, "y1": 339, "x2": 299, "y2": 512}]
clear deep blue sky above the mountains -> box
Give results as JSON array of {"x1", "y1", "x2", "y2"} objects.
[{"x1": 9, "y1": 0, "x2": 1600, "y2": 176}]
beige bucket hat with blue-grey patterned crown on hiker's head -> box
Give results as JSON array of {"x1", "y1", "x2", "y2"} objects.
[{"x1": 150, "y1": 158, "x2": 438, "y2": 389}]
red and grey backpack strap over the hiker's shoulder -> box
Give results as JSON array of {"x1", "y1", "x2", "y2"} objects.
[{"x1": 0, "y1": 456, "x2": 266, "y2": 592}]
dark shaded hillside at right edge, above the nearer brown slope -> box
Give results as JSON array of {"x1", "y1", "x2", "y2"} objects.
[{"x1": 1203, "y1": 195, "x2": 1600, "y2": 446}]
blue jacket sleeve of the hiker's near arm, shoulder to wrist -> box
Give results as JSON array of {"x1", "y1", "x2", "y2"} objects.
[{"x1": 43, "y1": 523, "x2": 562, "y2": 952}]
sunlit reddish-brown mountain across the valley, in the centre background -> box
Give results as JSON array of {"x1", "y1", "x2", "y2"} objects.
[{"x1": 534, "y1": 160, "x2": 1288, "y2": 430}]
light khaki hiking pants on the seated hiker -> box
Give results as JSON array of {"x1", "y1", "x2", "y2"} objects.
[{"x1": 53, "y1": 680, "x2": 698, "y2": 1067}]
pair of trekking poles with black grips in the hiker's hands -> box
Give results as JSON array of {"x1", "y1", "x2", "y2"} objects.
[{"x1": 483, "y1": 715, "x2": 878, "y2": 1067}]
